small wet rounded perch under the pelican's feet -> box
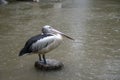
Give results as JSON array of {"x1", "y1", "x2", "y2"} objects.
[{"x1": 35, "y1": 59, "x2": 63, "y2": 71}]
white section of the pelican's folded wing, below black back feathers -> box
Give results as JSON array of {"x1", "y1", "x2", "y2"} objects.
[{"x1": 31, "y1": 36, "x2": 55, "y2": 52}]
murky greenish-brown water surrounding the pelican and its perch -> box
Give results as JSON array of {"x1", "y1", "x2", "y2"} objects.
[{"x1": 0, "y1": 0, "x2": 120, "y2": 80}]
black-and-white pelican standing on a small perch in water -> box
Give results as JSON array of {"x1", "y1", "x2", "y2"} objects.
[{"x1": 19, "y1": 25, "x2": 74, "y2": 64}]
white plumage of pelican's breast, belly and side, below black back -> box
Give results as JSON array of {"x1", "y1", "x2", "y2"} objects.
[{"x1": 32, "y1": 34, "x2": 62, "y2": 54}]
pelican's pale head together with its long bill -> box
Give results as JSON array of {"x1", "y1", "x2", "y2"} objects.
[{"x1": 42, "y1": 25, "x2": 74, "y2": 40}]
